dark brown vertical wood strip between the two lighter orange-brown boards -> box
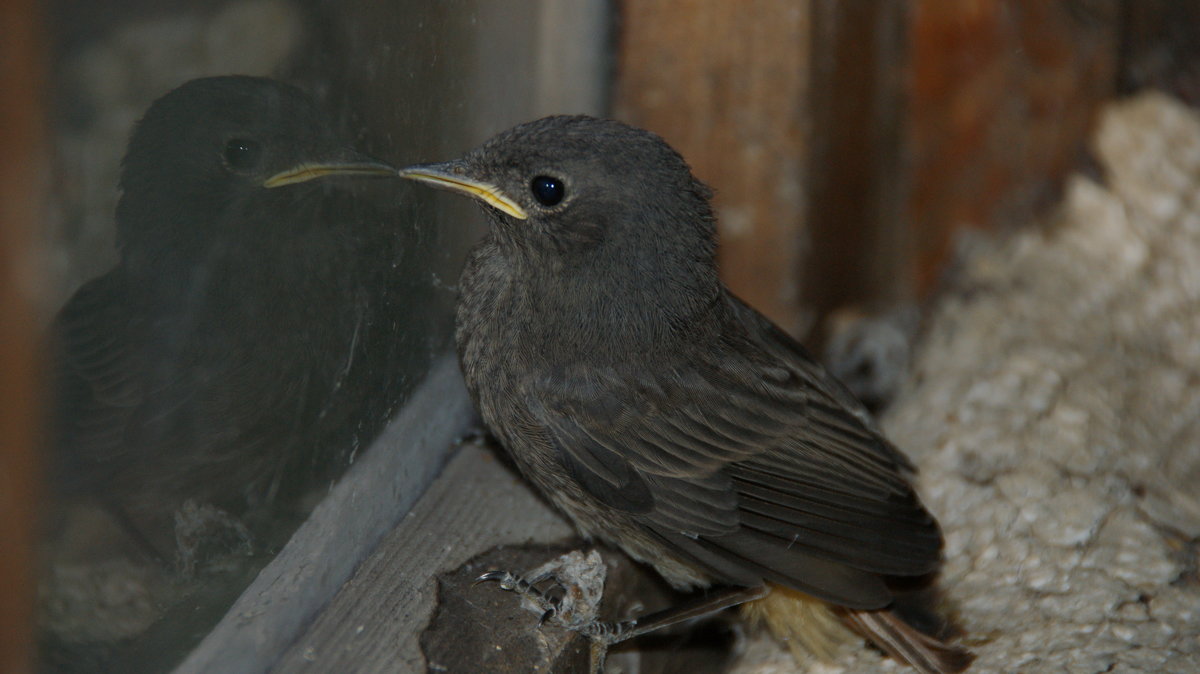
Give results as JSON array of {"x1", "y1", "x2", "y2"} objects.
[{"x1": 802, "y1": 0, "x2": 912, "y2": 328}]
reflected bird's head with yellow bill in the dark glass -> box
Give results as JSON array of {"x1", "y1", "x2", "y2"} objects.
[{"x1": 118, "y1": 76, "x2": 395, "y2": 250}]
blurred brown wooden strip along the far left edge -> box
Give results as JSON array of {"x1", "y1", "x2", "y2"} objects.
[{"x1": 0, "y1": 0, "x2": 48, "y2": 673}]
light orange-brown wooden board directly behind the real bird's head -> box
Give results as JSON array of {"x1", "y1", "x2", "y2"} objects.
[{"x1": 613, "y1": 0, "x2": 810, "y2": 331}]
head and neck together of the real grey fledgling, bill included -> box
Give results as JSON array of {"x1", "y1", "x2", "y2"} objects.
[{"x1": 400, "y1": 116, "x2": 721, "y2": 353}]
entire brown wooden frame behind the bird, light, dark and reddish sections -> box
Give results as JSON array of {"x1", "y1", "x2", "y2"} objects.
[{"x1": 614, "y1": 0, "x2": 1123, "y2": 332}]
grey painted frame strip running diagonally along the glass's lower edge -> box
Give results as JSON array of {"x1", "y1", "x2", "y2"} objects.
[{"x1": 175, "y1": 356, "x2": 470, "y2": 674}]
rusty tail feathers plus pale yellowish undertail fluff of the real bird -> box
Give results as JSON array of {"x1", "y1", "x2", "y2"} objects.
[{"x1": 742, "y1": 584, "x2": 973, "y2": 674}]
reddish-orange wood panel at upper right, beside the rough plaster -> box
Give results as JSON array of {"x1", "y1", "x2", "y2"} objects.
[{"x1": 900, "y1": 0, "x2": 1118, "y2": 293}]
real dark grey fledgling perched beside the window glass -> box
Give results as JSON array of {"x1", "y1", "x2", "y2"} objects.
[{"x1": 401, "y1": 116, "x2": 970, "y2": 673}]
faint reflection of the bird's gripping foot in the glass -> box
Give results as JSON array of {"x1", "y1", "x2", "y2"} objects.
[{"x1": 175, "y1": 499, "x2": 254, "y2": 578}]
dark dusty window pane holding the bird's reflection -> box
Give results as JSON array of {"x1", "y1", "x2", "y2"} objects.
[{"x1": 38, "y1": 0, "x2": 496, "y2": 672}]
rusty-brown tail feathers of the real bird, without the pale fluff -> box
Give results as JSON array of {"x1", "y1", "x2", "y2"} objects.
[{"x1": 838, "y1": 599, "x2": 974, "y2": 674}]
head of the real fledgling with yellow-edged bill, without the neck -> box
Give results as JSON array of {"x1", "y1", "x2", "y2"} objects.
[{"x1": 400, "y1": 115, "x2": 715, "y2": 269}]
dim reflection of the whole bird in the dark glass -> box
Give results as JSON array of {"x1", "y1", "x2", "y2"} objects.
[{"x1": 52, "y1": 77, "x2": 397, "y2": 563}]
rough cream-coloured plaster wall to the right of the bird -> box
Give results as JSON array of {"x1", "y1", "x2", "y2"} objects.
[{"x1": 737, "y1": 94, "x2": 1200, "y2": 674}]
